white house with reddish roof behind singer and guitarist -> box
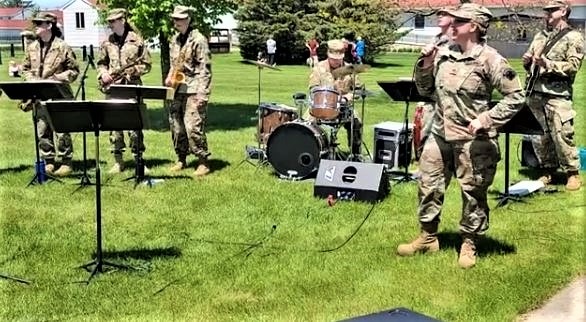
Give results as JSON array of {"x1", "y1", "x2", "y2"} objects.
[{"x1": 395, "y1": 0, "x2": 586, "y2": 57}]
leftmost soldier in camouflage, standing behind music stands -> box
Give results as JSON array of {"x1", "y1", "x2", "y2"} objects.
[{"x1": 22, "y1": 13, "x2": 79, "y2": 176}]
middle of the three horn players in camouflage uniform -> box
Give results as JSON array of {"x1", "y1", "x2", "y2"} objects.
[{"x1": 96, "y1": 8, "x2": 151, "y2": 174}]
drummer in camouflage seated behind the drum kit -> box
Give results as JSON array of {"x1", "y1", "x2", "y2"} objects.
[{"x1": 309, "y1": 39, "x2": 362, "y2": 155}]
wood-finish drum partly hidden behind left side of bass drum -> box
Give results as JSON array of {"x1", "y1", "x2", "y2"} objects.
[{"x1": 257, "y1": 103, "x2": 299, "y2": 144}]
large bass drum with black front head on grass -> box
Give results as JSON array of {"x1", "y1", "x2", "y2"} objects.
[{"x1": 267, "y1": 122, "x2": 328, "y2": 179}]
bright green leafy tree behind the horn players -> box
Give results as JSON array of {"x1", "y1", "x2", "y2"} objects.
[{"x1": 98, "y1": 0, "x2": 236, "y2": 83}]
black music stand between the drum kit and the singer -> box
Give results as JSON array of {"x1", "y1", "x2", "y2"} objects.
[{"x1": 377, "y1": 80, "x2": 433, "y2": 183}]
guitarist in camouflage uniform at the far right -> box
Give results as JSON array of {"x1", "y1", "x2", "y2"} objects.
[{"x1": 523, "y1": 0, "x2": 584, "y2": 191}]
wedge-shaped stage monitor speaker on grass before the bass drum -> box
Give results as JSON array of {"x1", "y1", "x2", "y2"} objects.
[{"x1": 313, "y1": 159, "x2": 390, "y2": 202}]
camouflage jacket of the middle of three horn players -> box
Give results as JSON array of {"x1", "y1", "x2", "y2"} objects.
[{"x1": 96, "y1": 31, "x2": 152, "y2": 84}]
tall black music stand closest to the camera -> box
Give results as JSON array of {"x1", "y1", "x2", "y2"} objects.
[{"x1": 46, "y1": 100, "x2": 144, "y2": 283}]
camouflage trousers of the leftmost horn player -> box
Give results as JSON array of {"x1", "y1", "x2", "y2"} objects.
[{"x1": 36, "y1": 104, "x2": 73, "y2": 162}]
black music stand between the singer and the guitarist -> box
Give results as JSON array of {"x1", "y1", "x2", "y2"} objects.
[{"x1": 496, "y1": 105, "x2": 545, "y2": 207}]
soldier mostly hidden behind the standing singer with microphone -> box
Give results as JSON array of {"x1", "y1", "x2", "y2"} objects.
[{"x1": 415, "y1": 8, "x2": 452, "y2": 160}]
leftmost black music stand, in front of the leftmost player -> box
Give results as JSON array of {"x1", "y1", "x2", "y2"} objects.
[{"x1": 0, "y1": 80, "x2": 73, "y2": 187}]
